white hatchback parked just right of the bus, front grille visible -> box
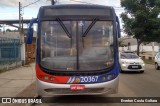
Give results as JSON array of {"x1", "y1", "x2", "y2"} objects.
[{"x1": 119, "y1": 52, "x2": 145, "y2": 73}]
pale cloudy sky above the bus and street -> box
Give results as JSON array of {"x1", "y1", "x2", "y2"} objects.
[{"x1": 0, "y1": 0, "x2": 123, "y2": 29}]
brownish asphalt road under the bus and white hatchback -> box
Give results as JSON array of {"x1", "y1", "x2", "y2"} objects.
[{"x1": 17, "y1": 64, "x2": 160, "y2": 106}]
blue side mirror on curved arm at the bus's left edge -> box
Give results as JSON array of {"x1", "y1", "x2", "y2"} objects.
[{"x1": 26, "y1": 18, "x2": 37, "y2": 44}]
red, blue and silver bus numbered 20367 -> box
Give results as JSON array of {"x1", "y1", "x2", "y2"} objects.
[{"x1": 27, "y1": 5, "x2": 120, "y2": 96}]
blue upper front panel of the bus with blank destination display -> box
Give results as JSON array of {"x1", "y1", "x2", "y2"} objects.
[{"x1": 38, "y1": 4, "x2": 114, "y2": 19}]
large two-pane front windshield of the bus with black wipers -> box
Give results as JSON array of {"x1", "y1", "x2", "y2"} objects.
[{"x1": 40, "y1": 20, "x2": 114, "y2": 71}]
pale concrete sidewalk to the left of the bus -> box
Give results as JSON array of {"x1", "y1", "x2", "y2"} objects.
[{"x1": 0, "y1": 63, "x2": 35, "y2": 97}]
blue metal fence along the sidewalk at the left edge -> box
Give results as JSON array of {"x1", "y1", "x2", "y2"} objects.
[{"x1": 0, "y1": 37, "x2": 21, "y2": 65}]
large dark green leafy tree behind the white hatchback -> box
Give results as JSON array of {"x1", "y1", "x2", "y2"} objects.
[{"x1": 121, "y1": 0, "x2": 160, "y2": 55}]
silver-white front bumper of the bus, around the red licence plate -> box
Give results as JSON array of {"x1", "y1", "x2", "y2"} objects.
[{"x1": 37, "y1": 77, "x2": 119, "y2": 97}]
